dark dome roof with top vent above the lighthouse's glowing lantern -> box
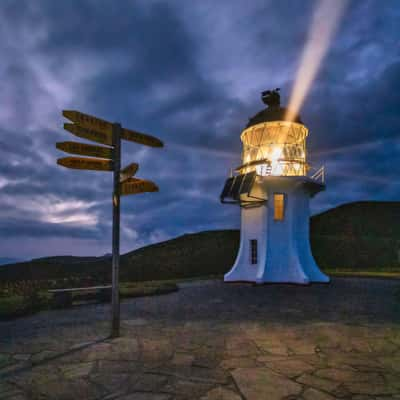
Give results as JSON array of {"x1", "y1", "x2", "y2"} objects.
[{"x1": 246, "y1": 88, "x2": 302, "y2": 128}]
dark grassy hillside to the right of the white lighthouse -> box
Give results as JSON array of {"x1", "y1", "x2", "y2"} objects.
[{"x1": 311, "y1": 201, "x2": 400, "y2": 270}]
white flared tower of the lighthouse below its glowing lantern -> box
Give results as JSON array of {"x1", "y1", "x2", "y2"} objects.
[{"x1": 224, "y1": 176, "x2": 330, "y2": 285}]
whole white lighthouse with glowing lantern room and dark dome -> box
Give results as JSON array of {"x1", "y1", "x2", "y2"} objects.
[{"x1": 221, "y1": 89, "x2": 329, "y2": 285}]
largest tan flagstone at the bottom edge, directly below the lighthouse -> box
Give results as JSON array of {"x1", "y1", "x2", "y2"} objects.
[{"x1": 232, "y1": 368, "x2": 302, "y2": 400}]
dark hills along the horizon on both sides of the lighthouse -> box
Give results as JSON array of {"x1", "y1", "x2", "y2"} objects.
[{"x1": 0, "y1": 202, "x2": 400, "y2": 281}]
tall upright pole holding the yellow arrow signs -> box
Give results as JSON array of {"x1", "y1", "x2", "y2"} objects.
[{"x1": 111, "y1": 123, "x2": 121, "y2": 337}]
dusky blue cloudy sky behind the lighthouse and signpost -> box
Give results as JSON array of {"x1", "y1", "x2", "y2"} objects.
[{"x1": 0, "y1": 0, "x2": 400, "y2": 258}]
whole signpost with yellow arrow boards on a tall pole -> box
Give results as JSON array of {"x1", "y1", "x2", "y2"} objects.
[{"x1": 56, "y1": 110, "x2": 163, "y2": 337}]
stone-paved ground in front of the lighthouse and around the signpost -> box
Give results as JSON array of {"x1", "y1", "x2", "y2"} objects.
[{"x1": 0, "y1": 279, "x2": 400, "y2": 400}]
